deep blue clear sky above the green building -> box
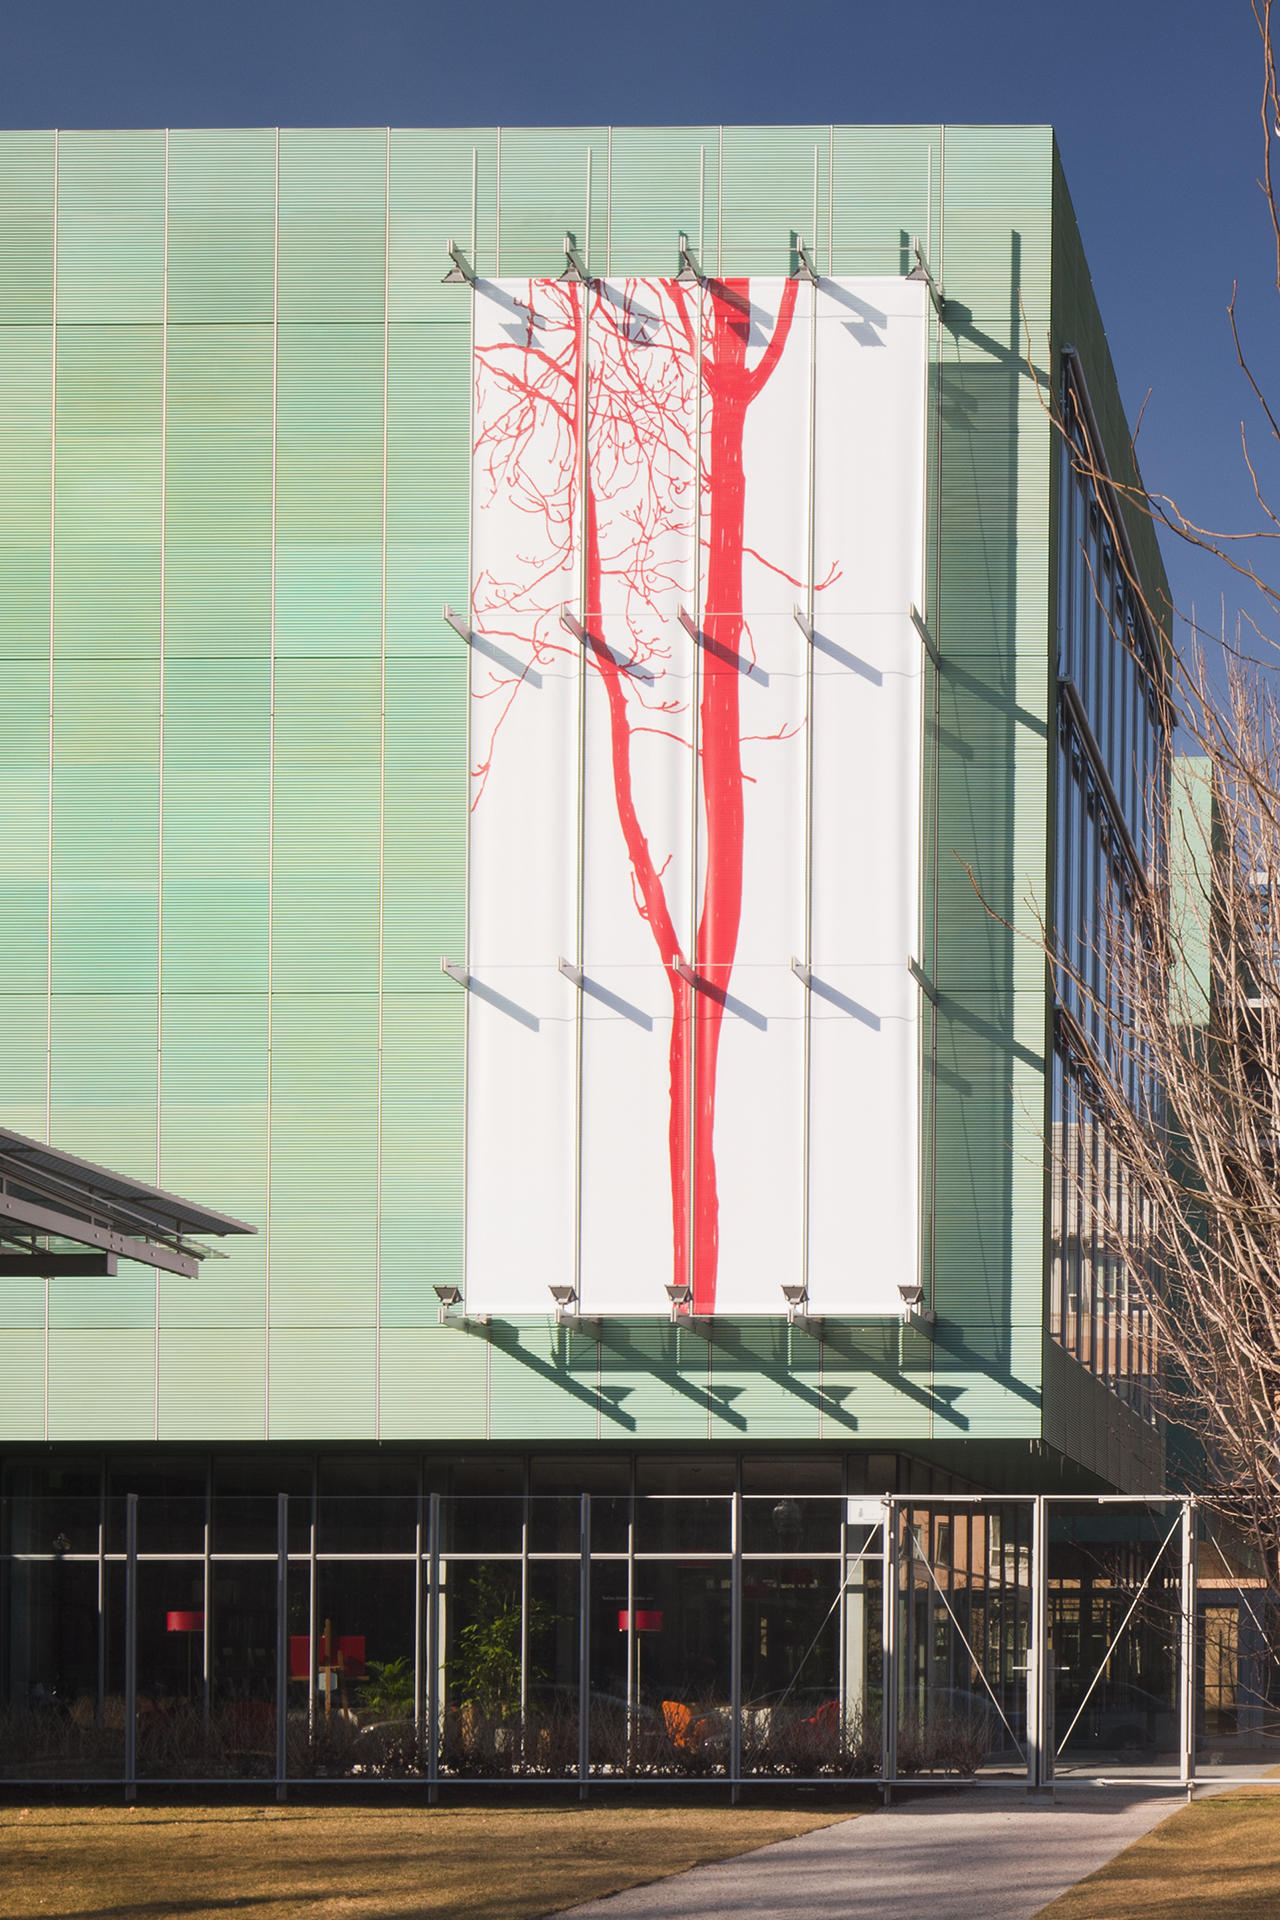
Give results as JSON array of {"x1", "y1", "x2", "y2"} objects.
[{"x1": 0, "y1": 0, "x2": 1280, "y2": 626}]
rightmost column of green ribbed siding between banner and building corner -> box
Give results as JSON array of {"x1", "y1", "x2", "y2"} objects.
[{"x1": 931, "y1": 129, "x2": 1052, "y2": 1434}]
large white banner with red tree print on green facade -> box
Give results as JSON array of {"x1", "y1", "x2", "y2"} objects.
[{"x1": 466, "y1": 280, "x2": 927, "y2": 1313}]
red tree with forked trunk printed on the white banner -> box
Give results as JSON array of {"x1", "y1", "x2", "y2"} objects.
[{"x1": 472, "y1": 280, "x2": 796, "y2": 1313}]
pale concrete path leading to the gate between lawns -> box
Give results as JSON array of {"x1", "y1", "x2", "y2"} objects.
[{"x1": 552, "y1": 1784, "x2": 1184, "y2": 1920}]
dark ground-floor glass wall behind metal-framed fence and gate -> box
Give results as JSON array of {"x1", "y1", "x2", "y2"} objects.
[{"x1": 0, "y1": 1490, "x2": 1276, "y2": 1795}]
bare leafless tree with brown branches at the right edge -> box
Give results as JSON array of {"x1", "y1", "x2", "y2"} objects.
[{"x1": 1044, "y1": 0, "x2": 1280, "y2": 1586}]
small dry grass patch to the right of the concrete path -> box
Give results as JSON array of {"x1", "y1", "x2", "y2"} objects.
[{"x1": 1036, "y1": 1788, "x2": 1280, "y2": 1920}]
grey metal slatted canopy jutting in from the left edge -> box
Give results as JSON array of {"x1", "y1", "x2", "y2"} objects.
[{"x1": 0, "y1": 1127, "x2": 257, "y2": 1281}]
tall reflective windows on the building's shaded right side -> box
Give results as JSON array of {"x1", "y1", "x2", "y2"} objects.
[{"x1": 1050, "y1": 361, "x2": 1169, "y2": 1419}]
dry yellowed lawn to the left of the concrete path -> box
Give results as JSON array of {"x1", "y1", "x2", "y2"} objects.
[{"x1": 0, "y1": 1805, "x2": 859, "y2": 1920}]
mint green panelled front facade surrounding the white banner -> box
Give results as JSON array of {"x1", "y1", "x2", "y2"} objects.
[{"x1": 0, "y1": 127, "x2": 1159, "y2": 1486}]
